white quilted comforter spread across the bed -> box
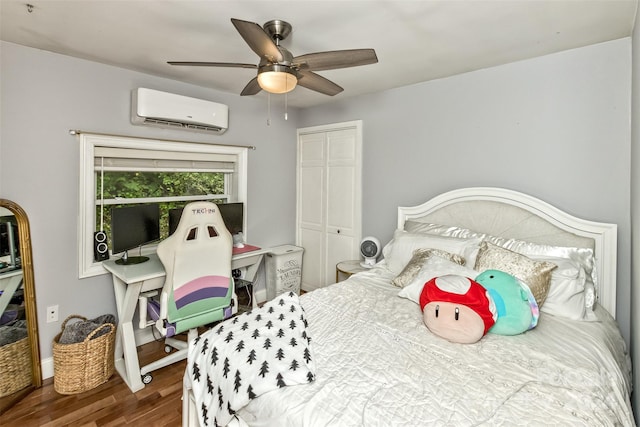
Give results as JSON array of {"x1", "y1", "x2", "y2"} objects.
[{"x1": 192, "y1": 267, "x2": 635, "y2": 427}]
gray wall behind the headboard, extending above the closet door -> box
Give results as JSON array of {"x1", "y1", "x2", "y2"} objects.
[{"x1": 299, "y1": 38, "x2": 631, "y2": 343}]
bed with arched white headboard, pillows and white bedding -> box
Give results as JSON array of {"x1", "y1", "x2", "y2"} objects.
[{"x1": 183, "y1": 188, "x2": 635, "y2": 427}]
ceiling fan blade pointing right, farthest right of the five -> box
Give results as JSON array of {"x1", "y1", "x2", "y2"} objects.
[{"x1": 292, "y1": 49, "x2": 378, "y2": 71}]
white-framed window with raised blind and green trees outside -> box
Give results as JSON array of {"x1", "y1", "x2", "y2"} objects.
[{"x1": 78, "y1": 133, "x2": 248, "y2": 278}]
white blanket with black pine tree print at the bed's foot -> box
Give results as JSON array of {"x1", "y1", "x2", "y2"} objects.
[{"x1": 187, "y1": 292, "x2": 315, "y2": 427}]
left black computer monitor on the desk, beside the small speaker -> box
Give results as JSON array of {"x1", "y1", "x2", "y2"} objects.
[{"x1": 111, "y1": 203, "x2": 160, "y2": 264}]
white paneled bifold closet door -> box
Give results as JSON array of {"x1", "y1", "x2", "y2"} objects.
[{"x1": 296, "y1": 121, "x2": 362, "y2": 291}]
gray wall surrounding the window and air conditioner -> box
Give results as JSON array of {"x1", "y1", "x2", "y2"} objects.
[{"x1": 0, "y1": 42, "x2": 298, "y2": 358}]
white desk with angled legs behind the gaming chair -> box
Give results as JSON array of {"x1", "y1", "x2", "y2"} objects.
[{"x1": 102, "y1": 249, "x2": 270, "y2": 393}]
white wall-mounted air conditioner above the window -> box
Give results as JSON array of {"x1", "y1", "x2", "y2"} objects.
[{"x1": 131, "y1": 87, "x2": 229, "y2": 134}]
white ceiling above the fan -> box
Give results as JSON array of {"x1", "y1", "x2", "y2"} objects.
[{"x1": 0, "y1": 0, "x2": 638, "y2": 107}]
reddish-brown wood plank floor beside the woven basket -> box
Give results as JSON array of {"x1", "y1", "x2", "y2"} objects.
[{"x1": 0, "y1": 342, "x2": 186, "y2": 427}]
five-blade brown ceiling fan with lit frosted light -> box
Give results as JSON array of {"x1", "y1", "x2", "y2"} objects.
[{"x1": 167, "y1": 18, "x2": 378, "y2": 96}]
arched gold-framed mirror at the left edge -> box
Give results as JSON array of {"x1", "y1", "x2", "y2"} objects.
[{"x1": 0, "y1": 199, "x2": 42, "y2": 414}]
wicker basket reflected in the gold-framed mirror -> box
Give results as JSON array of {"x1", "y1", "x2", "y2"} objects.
[{"x1": 0, "y1": 337, "x2": 32, "y2": 397}]
